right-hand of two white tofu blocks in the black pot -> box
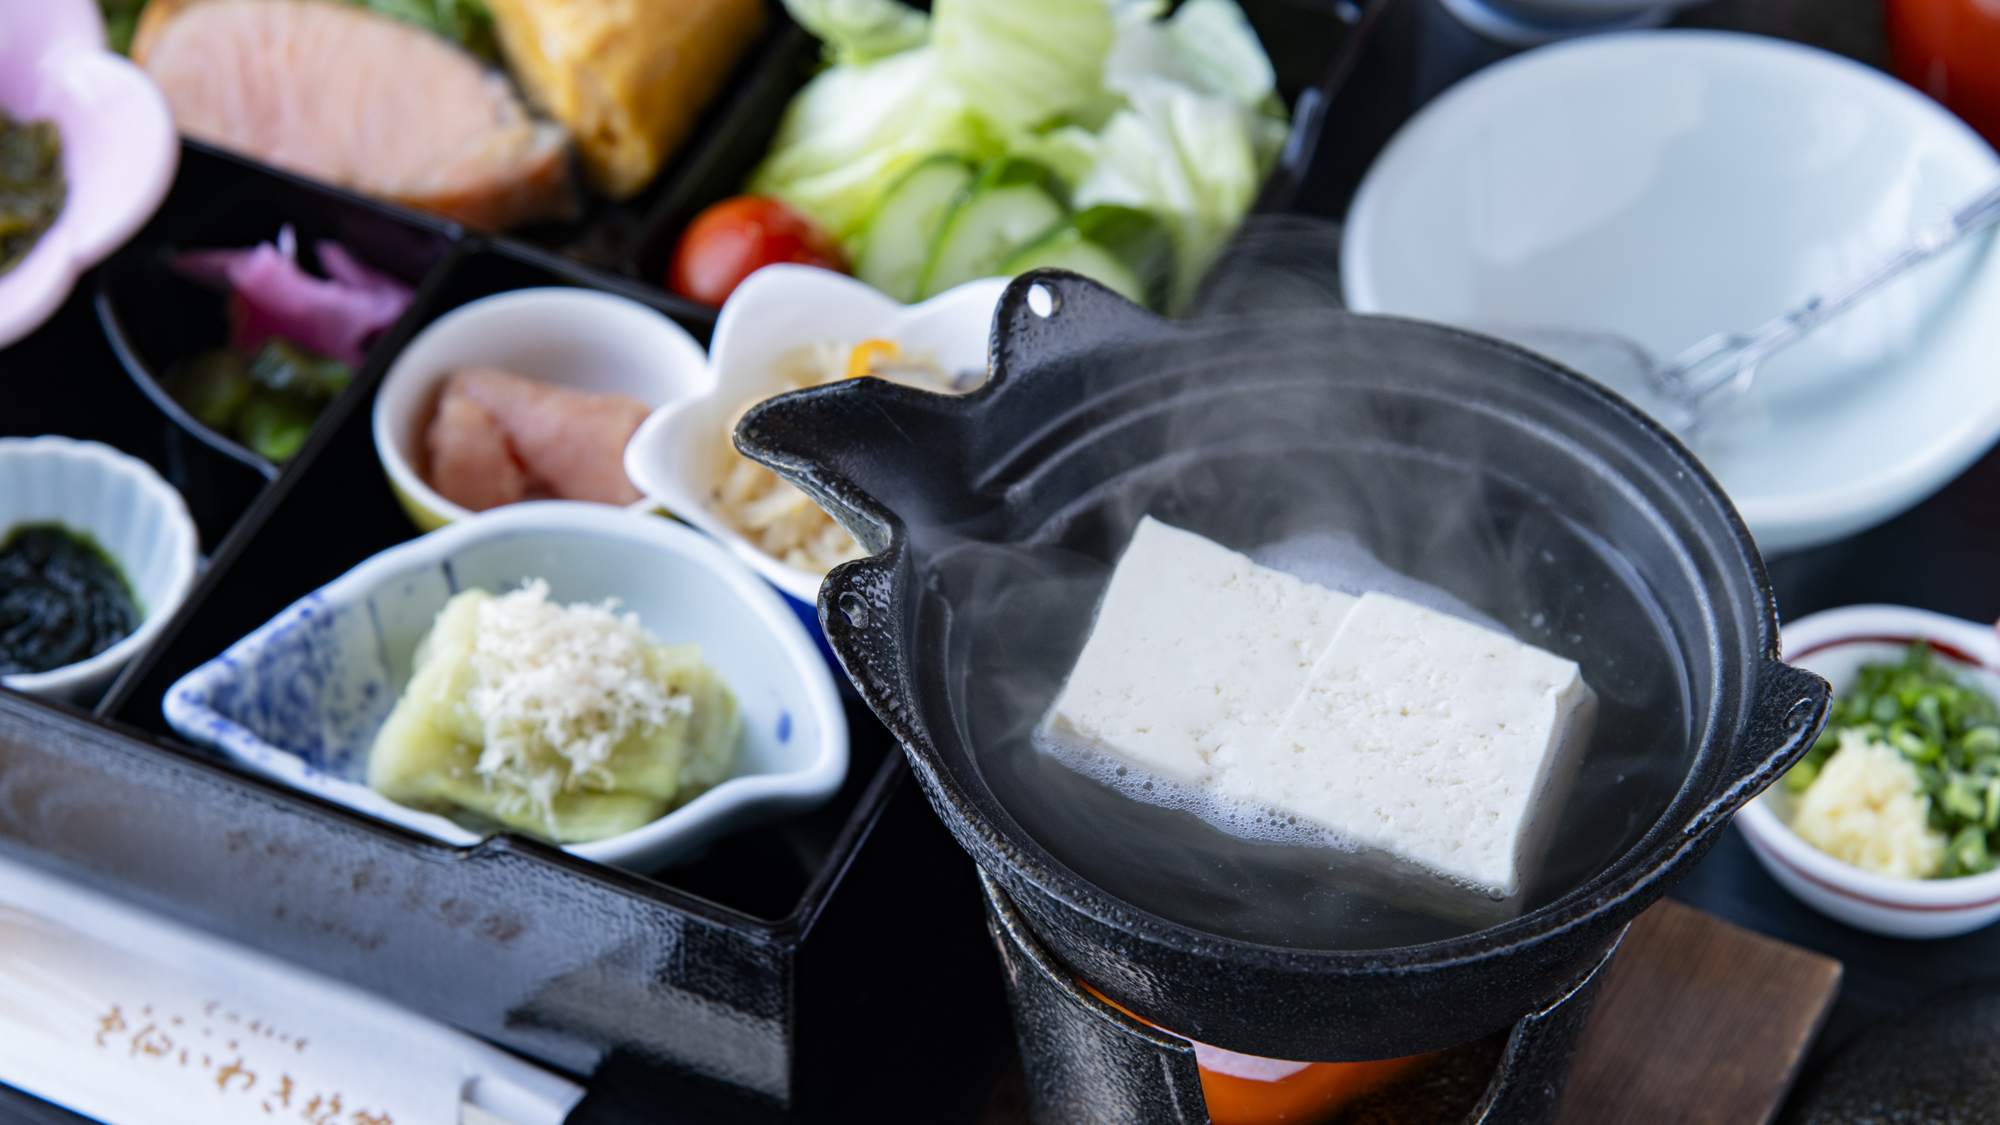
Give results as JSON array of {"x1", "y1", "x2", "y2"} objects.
[{"x1": 1216, "y1": 593, "x2": 1596, "y2": 897}]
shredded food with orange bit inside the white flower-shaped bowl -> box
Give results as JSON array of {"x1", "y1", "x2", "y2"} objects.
[{"x1": 714, "y1": 340, "x2": 960, "y2": 575}]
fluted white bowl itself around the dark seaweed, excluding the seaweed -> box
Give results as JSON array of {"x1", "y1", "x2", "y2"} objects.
[{"x1": 0, "y1": 436, "x2": 200, "y2": 701}]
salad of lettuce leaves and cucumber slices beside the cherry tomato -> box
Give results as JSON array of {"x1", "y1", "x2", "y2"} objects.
[{"x1": 750, "y1": 0, "x2": 1288, "y2": 308}]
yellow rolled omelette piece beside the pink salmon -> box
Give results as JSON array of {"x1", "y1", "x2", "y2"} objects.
[{"x1": 486, "y1": 0, "x2": 764, "y2": 198}]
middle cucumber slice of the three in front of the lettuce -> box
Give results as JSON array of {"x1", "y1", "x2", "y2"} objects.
[{"x1": 916, "y1": 160, "x2": 1066, "y2": 298}]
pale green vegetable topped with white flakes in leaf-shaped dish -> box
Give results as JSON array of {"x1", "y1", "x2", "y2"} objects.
[{"x1": 368, "y1": 581, "x2": 742, "y2": 843}]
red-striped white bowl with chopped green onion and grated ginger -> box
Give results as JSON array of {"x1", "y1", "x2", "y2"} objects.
[{"x1": 1736, "y1": 605, "x2": 2000, "y2": 937}]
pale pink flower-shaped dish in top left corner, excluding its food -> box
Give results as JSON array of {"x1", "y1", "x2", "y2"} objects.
[{"x1": 0, "y1": 0, "x2": 180, "y2": 348}]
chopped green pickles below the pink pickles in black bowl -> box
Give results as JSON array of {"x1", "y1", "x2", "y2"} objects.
[{"x1": 166, "y1": 336, "x2": 354, "y2": 460}]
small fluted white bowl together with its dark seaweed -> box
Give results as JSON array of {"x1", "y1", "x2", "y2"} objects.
[{"x1": 0, "y1": 436, "x2": 196, "y2": 701}]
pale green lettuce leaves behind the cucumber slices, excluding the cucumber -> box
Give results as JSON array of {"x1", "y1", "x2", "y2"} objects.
[{"x1": 750, "y1": 0, "x2": 1288, "y2": 308}]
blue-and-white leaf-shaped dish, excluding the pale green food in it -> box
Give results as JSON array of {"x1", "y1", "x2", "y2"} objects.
[{"x1": 164, "y1": 500, "x2": 848, "y2": 871}]
